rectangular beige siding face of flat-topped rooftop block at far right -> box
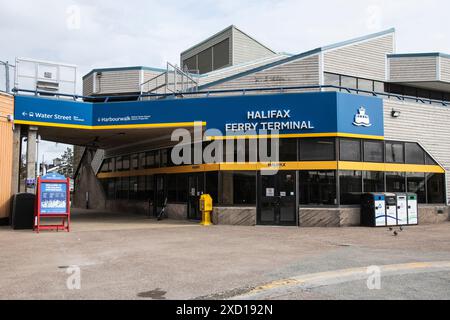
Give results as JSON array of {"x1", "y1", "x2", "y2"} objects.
[{"x1": 389, "y1": 57, "x2": 437, "y2": 82}]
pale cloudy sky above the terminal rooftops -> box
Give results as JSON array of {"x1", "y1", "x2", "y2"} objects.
[{"x1": 0, "y1": 0, "x2": 450, "y2": 159}]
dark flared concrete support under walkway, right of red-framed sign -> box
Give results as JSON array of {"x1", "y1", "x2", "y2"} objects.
[{"x1": 72, "y1": 150, "x2": 106, "y2": 210}]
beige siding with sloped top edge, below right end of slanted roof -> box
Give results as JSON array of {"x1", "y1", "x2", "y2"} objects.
[{"x1": 324, "y1": 34, "x2": 394, "y2": 81}]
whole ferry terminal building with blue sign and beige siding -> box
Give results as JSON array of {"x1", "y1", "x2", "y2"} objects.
[{"x1": 0, "y1": 26, "x2": 450, "y2": 227}]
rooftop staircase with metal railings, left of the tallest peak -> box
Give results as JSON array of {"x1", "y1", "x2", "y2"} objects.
[{"x1": 141, "y1": 63, "x2": 198, "y2": 95}]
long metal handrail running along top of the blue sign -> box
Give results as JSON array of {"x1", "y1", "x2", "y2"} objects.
[{"x1": 12, "y1": 85, "x2": 450, "y2": 107}]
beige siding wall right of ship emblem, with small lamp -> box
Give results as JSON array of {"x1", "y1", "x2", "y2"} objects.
[{"x1": 384, "y1": 100, "x2": 450, "y2": 199}]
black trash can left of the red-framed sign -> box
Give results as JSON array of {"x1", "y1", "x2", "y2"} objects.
[{"x1": 9, "y1": 193, "x2": 36, "y2": 230}]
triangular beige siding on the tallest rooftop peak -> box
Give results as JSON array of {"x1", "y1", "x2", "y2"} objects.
[{"x1": 233, "y1": 28, "x2": 274, "y2": 65}]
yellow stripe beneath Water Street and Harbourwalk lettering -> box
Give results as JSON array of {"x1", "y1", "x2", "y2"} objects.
[{"x1": 14, "y1": 120, "x2": 206, "y2": 130}]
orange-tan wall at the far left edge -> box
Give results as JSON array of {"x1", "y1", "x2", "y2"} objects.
[{"x1": 0, "y1": 92, "x2": 14, "y2": 224}]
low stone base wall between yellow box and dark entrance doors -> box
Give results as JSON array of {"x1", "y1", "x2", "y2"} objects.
[{"x1": 212, "y1": 207, "x2": 256, "y2": 226}]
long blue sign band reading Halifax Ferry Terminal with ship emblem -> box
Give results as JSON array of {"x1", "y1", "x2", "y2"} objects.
[{"x1": 15, "y1": 92, "x2": 384, "y2": 138}]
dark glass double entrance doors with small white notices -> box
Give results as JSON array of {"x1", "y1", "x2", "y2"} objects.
[{"x1": 258, "y1": 171, "x2": 298, "y2": 226}]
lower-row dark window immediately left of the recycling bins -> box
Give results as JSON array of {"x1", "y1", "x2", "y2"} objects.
[{"x1": 339, "y1": 171, "x2": 362, "y2": 205}]
